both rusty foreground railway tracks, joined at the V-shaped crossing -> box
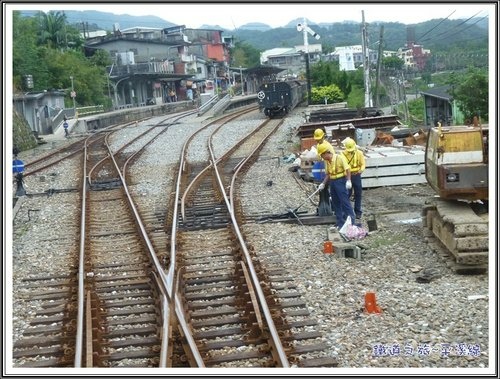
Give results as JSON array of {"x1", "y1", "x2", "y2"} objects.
[{"x1": 14, "y1": 108, "x2": 336, "y2": 367}]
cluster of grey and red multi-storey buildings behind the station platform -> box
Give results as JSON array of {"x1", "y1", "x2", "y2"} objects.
[{"x1": 85, "y1": 25, "x2": 229, "y2": 109}]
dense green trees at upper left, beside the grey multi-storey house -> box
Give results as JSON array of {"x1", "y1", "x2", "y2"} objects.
[{"x1": 13, "y1": 12, "x2": 111, "y2": 107}]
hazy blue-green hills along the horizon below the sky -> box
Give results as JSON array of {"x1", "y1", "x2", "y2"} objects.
[{"x1": 21, "y1": 11, "x2": 488, "y2": 52}]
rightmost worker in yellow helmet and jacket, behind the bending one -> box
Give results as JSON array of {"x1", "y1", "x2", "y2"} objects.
[{"x1": 342, "y1": 137, "x2": 366, "y2": 222}]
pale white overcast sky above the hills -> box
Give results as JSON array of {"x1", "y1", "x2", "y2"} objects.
[{"x1": 9, "y1": 2, "x2": 495, "y2": 29}]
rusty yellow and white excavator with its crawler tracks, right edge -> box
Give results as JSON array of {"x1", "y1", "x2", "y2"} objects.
[{"x1": 422, "y1": 118, "x2": 489, "y2": 274}]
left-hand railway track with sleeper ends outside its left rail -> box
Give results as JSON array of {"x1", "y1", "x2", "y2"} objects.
[{"x1": 13, "y1": 113, "x2": 194, "y2": 367}]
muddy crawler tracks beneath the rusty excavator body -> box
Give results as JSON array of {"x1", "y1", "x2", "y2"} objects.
[{"x1": 422, "y1": 198, "x2": 489, "y2": 274}]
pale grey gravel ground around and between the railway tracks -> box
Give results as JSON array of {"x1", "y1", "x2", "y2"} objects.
[{"x1": 7, "y1": 108, "x2": 495, "y2": 375}]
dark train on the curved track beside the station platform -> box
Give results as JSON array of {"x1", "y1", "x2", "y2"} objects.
[{"x1": 257, "y1": 80, "x2": 307, "y2": 117}]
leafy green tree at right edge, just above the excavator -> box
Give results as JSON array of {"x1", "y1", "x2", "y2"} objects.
[{"x1": 448, "y1": 67, "x2": 488, "y2": 120}]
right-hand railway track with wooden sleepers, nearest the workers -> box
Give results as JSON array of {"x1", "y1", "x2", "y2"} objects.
[{"x1": 170, "y1": 116, "x2": 336, "y2": 367}]
